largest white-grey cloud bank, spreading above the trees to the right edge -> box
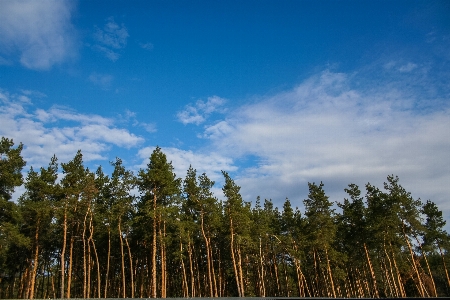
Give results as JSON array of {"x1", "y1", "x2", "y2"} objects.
[{"x1": 198, "y1": 71, "x2": 450, "y2": 220}]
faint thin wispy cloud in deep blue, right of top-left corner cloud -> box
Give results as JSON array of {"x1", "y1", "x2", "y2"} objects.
[{"x1": 93, "y1": 17, "x2": 129, "y2": 61}]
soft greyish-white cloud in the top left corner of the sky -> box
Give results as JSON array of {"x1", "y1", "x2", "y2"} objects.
[{"x1": 0, "y1": 0, "x2": 76, "y2": 70}]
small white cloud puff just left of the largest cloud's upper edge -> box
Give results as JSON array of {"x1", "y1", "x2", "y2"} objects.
[{"x1": 177, "y1": 96, "x2": 226, "y2": 125}]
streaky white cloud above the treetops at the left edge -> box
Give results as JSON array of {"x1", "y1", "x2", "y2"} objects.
[{"x1": 0, "y1": 90, "x2": 144, "y2": 167}]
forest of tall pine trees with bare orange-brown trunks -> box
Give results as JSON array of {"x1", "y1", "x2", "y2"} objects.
[{"x1": 0, "y1": 137, "x2": 450, "y2": 299}]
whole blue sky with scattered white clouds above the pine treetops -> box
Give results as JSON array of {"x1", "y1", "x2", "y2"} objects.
[{"x1": 0, "y1": 0, "x2": 450, "y2": 228}]
